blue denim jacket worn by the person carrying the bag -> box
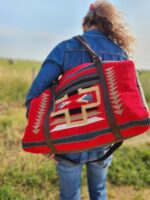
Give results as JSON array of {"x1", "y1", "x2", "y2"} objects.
[{"x1": 26, "y1": 30, "x2": 127, "y2": 162}]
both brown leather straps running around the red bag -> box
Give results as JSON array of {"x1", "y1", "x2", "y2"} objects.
[{"x1": 45, "y1": 36, "x2": 123, "y2": 161}]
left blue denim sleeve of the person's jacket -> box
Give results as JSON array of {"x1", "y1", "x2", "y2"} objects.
[{"x1": 25, "y1": 43, "x2": 65, "y2": 112}]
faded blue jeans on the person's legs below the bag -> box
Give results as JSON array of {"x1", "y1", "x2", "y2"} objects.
[{"x1": 57, "y1": 148, "x2": 112, "y2": 200}]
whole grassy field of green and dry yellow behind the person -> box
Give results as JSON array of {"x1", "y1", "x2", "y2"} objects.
[{"x1": 0, "y1": 59, "x2": 150, "y2": 200}]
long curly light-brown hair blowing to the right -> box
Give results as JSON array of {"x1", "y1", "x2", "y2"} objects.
[{"x1": 83, "y1": 0, "x2": 135, "y2": 54}]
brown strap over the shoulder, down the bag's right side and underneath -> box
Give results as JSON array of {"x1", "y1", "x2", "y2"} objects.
[{"x1": 56, "y1": 35, "x2": 123, "y2": 164}]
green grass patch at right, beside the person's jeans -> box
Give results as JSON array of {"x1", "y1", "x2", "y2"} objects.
[{"x1": 108, "y1": 144, "x2": 150, "y2": 189}]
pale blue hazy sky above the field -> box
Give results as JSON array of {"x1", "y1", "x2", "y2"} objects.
[{"x1": 0, "y1": 0, "x2": 150, "y2": 69}]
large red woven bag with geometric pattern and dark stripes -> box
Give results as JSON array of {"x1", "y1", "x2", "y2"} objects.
[{"x1": 22, "y1": 35, "x2": 150, "y2": 158}]
